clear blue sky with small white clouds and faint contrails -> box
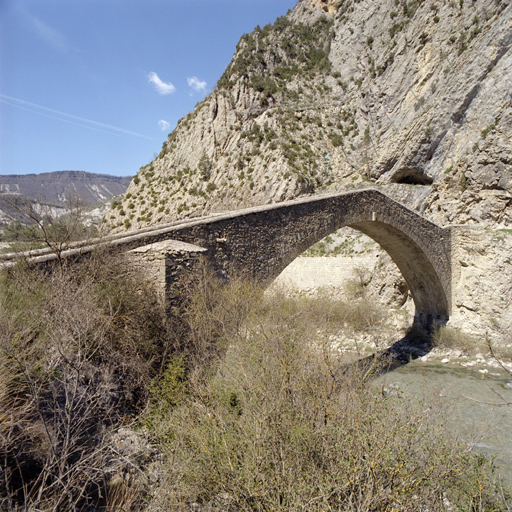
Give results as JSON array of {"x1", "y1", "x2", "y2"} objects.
[{"x1": 0, "y1": 0, "x2": 297, "y2": 176}]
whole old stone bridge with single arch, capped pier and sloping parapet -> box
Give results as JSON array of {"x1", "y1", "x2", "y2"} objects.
[{"x1": 3, "y1": 189, "x2": 452, "y2": 324}]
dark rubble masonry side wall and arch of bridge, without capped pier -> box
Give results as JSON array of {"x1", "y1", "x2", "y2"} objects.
[{"x1": 153, "y1": 190, "x2": 451, "y2": 322}]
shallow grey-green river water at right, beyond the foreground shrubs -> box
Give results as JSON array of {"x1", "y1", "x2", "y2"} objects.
[{"x1": 375, "y1": 360, "x2": 512, "y2": 485}]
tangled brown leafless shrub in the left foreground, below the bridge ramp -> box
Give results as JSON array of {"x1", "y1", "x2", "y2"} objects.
[{"x1": 0, "y1": 255, "x2": 173, "y2": 510}]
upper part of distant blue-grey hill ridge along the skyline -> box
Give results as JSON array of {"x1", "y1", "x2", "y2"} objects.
[{"x1": 0, "y1": 171, "x2": 132, "y2": 205}]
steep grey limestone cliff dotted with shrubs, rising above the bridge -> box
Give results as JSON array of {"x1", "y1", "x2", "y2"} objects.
[{"x1": 107, "y1": 0, "x2": 512, "y2": 230}]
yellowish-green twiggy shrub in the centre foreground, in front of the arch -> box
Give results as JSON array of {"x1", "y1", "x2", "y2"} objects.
[{"x1": 148, "y1": 278, "x2": 507, "y2": 512}]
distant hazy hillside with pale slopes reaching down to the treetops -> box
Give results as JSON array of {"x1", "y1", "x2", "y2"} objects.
[{"x1": 0, "y1": 171, "x2": 132, "y2": 222}]
